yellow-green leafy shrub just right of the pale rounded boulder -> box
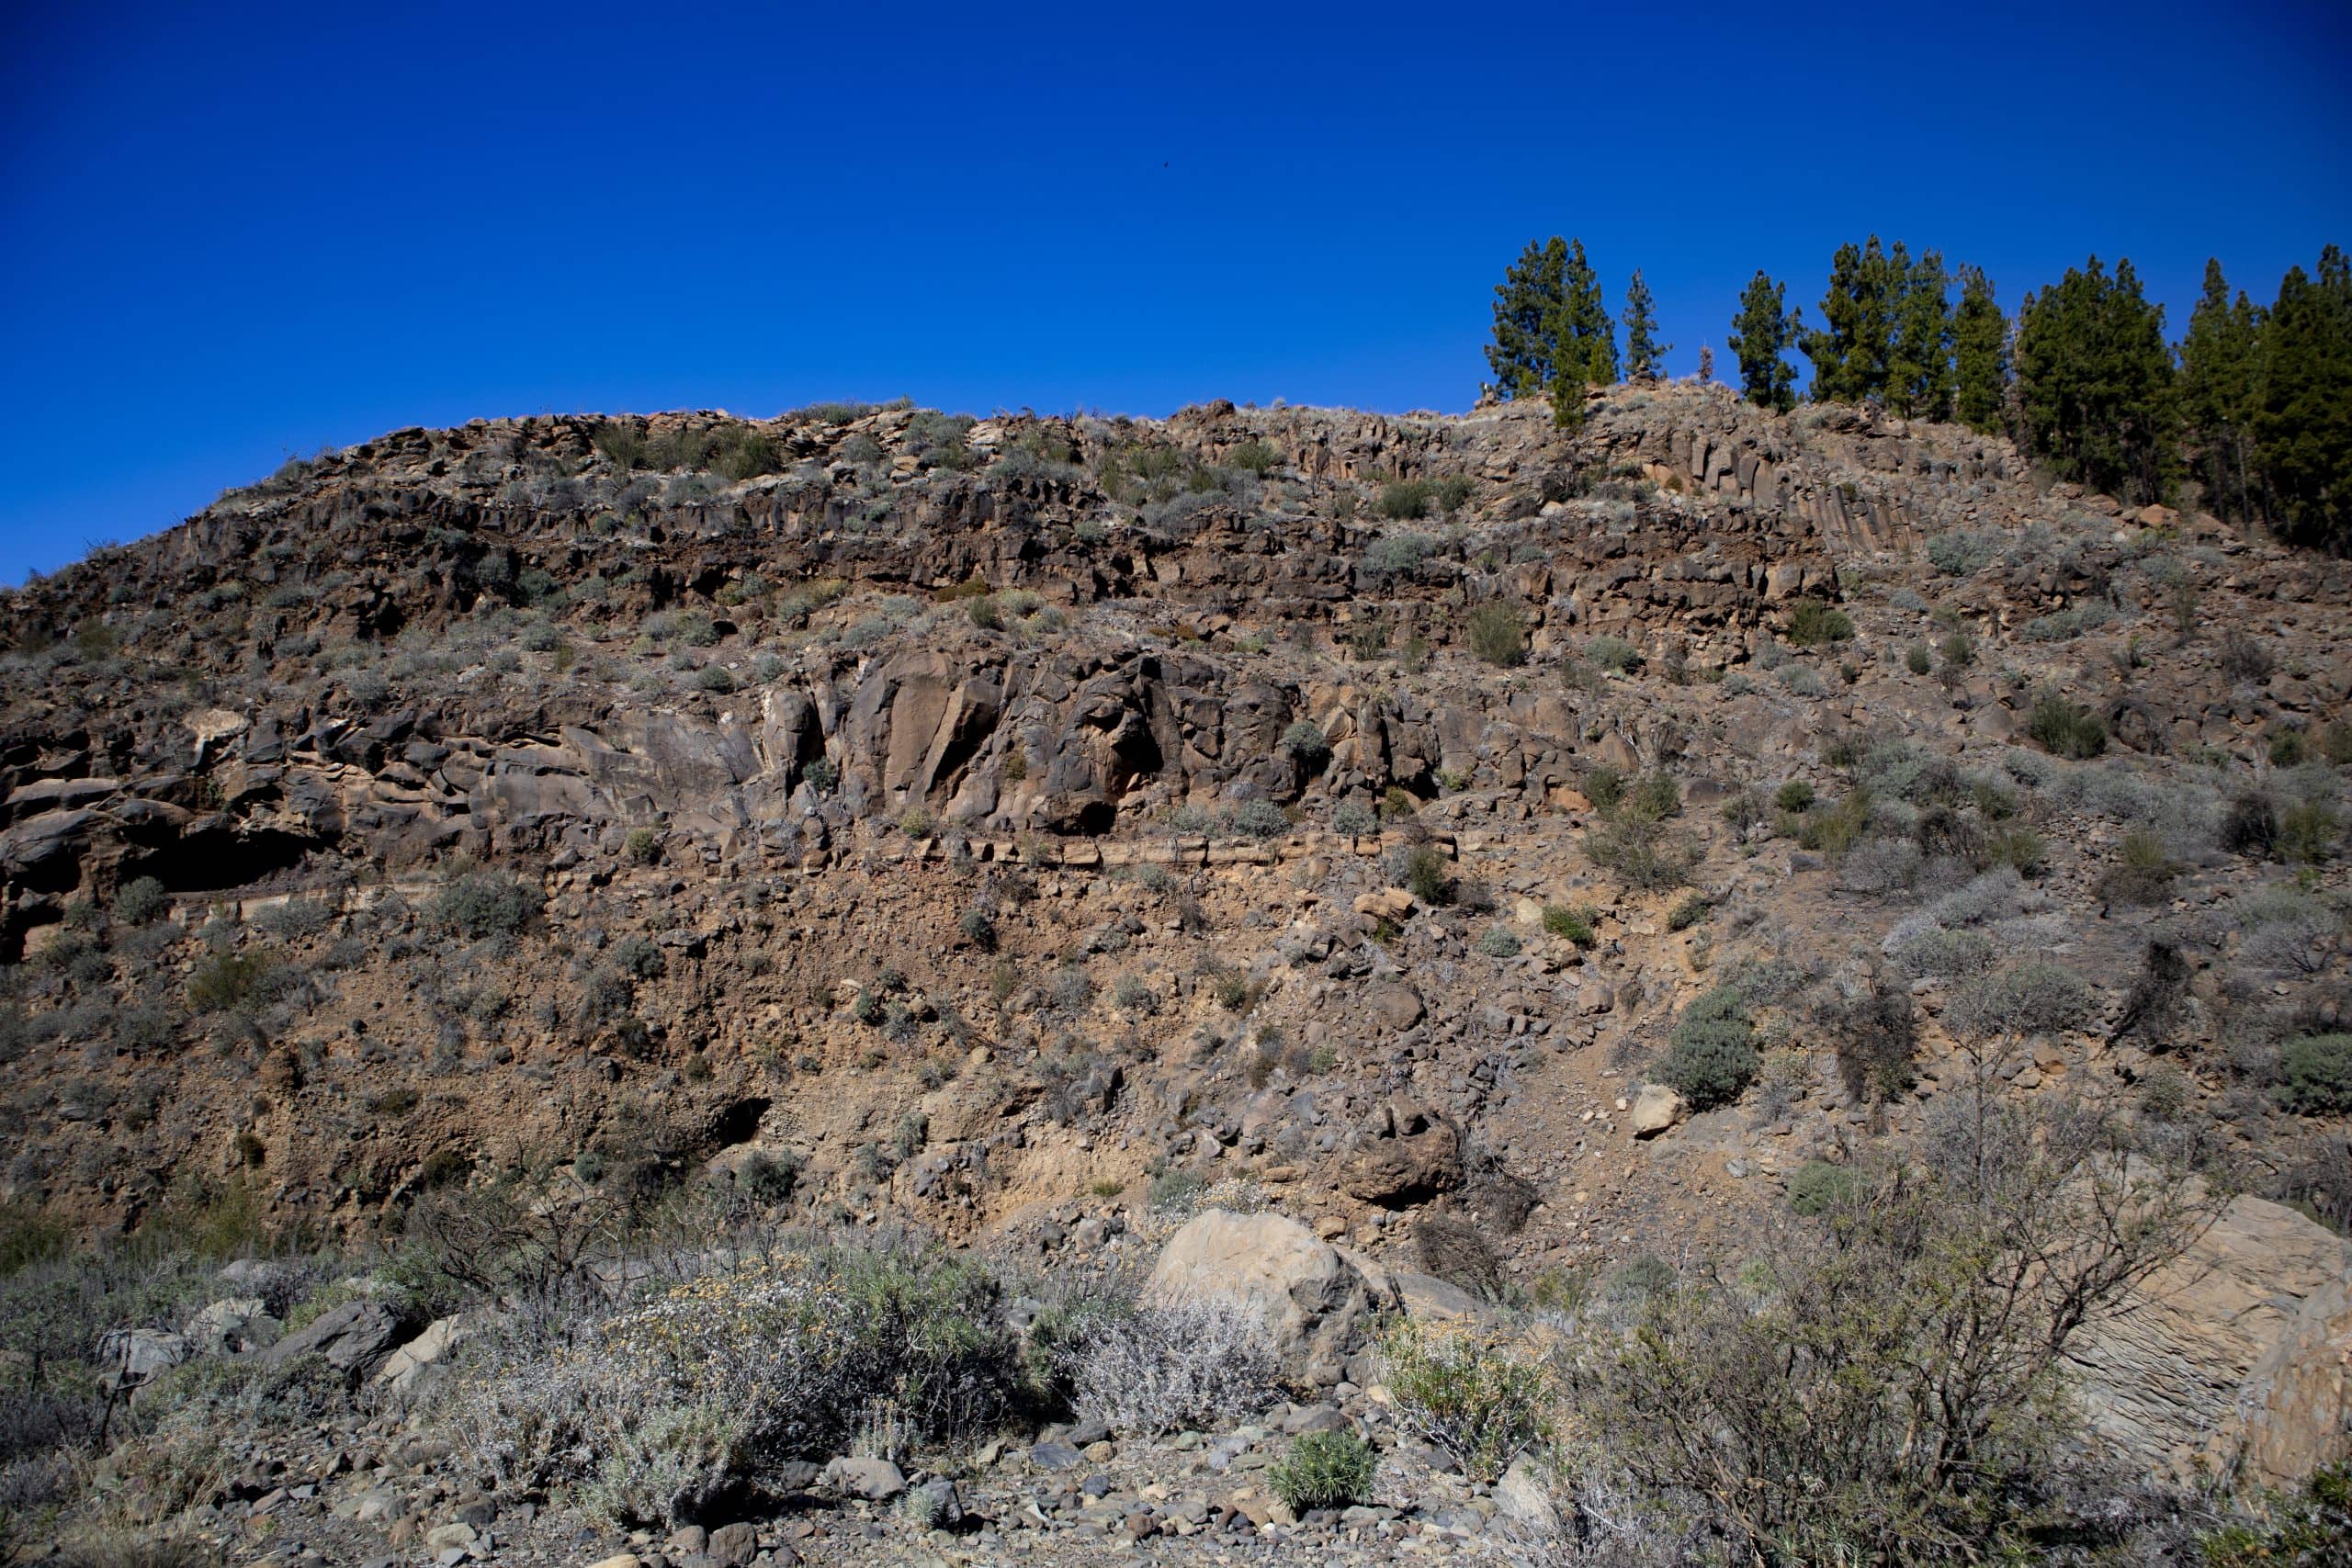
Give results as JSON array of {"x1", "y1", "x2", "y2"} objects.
[{"x1": 1378, "y1": 1319, "x2": 1553, "y2": 1481}]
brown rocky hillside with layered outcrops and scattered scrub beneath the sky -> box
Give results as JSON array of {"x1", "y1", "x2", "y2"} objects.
[{"x1": 0, "y1": 386, "x2": 2352, "y2": 1568}]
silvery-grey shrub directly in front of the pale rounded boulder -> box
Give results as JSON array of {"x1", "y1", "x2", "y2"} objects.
[{"x1": 1072, "y1": 1300, "x2": 1280, "y2": 1437}]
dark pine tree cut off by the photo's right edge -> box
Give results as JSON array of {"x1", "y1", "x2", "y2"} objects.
[{"x1": 2253, "y1": 244, "x2": 2352, "y2": 550}]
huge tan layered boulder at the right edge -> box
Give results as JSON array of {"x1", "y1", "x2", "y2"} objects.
[{"x1": 2072, "y1": 1197, "x2": 2352, "y2": 1483}]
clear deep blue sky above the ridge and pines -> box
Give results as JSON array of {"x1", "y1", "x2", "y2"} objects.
[{"x1": 0, "y1": 0, "x2": 2352, "y2": 581}]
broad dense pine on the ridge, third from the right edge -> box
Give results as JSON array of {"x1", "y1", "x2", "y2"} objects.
[{"x1": 2016, "y1": 256, "x2": 2173, "y2": 501}]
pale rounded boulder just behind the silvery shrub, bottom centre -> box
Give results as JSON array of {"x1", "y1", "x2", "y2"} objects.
[{"x1": 1143, "y1": 1208, "x2": 1402, "y2": 1387}]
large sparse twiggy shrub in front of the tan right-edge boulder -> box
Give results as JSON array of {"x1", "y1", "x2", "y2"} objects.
[{"x1": 1559, "y1": 1102, "x2": 2218, "y2": 1563}]
